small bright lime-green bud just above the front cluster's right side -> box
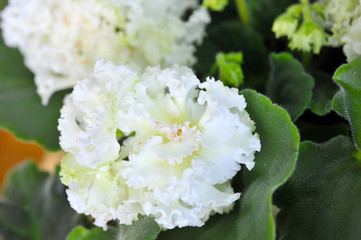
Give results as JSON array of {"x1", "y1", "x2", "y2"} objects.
[{"x1": 212, "y1": 52, "x2": 243, "y2": 88}]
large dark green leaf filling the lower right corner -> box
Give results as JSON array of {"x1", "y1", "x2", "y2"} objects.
[{"x1": 275, "y1": 136, "x2": 361, "y2": 240}]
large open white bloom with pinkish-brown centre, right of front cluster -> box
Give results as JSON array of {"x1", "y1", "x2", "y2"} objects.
[{"x1": 118, "y1": 67, "x2": 260, "y2": 228}]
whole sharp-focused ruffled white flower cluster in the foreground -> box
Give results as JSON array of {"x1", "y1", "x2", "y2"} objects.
[{"x1": 58, "y1": 60, "x2": 261, "y2": 229}]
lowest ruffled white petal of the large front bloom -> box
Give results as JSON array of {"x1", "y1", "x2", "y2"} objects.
[{"x1": 142, "y1": 169, "x2": 240, "y2": 229}]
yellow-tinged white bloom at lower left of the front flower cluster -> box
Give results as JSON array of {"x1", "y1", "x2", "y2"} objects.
[{"x1": 61, "y1": 154, "x2": 142, "y2": 229}]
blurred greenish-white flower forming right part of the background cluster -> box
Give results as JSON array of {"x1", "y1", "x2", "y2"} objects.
[{"x1": 118, "y1": 0, "x2": 210, "y2": 68}]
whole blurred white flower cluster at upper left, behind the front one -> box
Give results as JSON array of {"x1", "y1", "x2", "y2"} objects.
[{"x1": 1, "y1": 0, "x2": 210, "y2": 104}]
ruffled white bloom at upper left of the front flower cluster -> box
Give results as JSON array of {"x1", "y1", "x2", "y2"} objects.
[{"x1": 58, "y1": 60, "x2": 138, "y2": 169}]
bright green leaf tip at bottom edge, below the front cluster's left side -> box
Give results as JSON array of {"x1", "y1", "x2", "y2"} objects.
[{"x1": 66, "y1": 226, "x2": 118, "y2": 240}]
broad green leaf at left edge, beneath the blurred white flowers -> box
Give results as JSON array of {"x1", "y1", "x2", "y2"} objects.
[{"x1": 0, "y1": 34, "x2": 66, "y2": 150}]
